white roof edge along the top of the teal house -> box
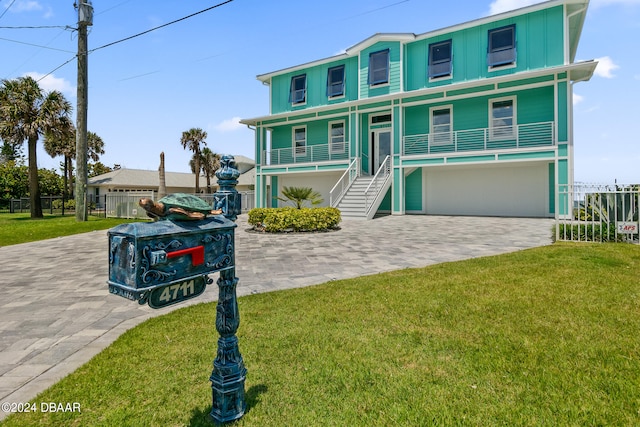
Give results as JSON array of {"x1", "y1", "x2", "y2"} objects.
[{"x1": 256, "y1": 0, "x2": 589, "y2": 85}]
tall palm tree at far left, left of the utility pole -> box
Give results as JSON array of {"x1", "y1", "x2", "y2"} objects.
[{"x1": 0, "y1": 77, "x2": 71, "y2": 218}]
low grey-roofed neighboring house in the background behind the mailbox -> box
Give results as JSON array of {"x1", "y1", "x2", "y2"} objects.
[{"x1": 87, "y1": 156, "x2": 255, "y2": 200}]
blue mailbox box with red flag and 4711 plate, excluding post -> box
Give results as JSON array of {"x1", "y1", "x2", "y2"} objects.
[{"x1": 108, "y1": 219, "x2": 236, "y2": 308}]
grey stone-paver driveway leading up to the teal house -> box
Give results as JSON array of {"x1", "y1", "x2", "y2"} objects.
[{"x1": 0, "y1": 215, "x2": 553, "y2": 420}]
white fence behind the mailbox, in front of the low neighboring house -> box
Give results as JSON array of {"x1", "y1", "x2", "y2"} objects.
[{"x1": 105, "y1": 191, "x2": 255, "y2": 219}]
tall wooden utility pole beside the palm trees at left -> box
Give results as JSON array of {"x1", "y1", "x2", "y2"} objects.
[{"x1": 74, "y1": 0, "x2": 93, "y2": 222}]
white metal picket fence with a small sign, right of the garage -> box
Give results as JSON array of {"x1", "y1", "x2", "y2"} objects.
[{"x1": 555, "y1": 184, "x2": 640, "y2": 244}]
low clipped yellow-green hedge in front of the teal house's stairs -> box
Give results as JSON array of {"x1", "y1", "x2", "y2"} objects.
[{"x1": 249, "y1": 207, "x2": 341, "y2": 233}]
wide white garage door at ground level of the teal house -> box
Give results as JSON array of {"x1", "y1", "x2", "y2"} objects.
[{"x1": 423, "y1": 163, "x2": 550, "y2": 217}]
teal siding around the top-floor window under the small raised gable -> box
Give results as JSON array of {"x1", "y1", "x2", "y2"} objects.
[{"x1": 360, "y1": 41, "x2": 401, "y2": 99}]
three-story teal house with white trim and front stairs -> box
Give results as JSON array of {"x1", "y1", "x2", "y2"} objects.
[{"x1": 241, "y1": 0, "x2": 597, "y2": 218}]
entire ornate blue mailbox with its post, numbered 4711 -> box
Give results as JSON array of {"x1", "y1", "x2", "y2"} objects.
[{"x1": 107, "y1": 156, "x2": 247, "y2": 422}]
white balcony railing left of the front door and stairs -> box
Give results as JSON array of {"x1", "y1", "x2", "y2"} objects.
[{"x1": 261, "y1": 141, "x2": 350, "y2": 165}]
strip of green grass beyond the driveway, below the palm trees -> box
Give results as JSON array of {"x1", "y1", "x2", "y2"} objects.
[{"x1": 0, "y1": 213, "x2": 139, "y2": 246}]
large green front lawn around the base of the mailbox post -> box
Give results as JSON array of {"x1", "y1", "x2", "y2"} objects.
[{"x1": 3, "y1": 244, "x2": 640, "y2": 427}]
